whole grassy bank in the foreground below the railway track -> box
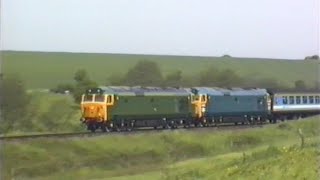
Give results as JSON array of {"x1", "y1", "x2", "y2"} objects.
[{"x1": 1, "y1": 117, "x2": 320, "y2": 179}]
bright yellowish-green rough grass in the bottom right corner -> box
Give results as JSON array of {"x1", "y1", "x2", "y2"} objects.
[{"x1": 162, "y1": 141, "x2": 320, "y2": 180}]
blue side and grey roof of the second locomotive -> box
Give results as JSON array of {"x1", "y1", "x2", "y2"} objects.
[{"x1": 192, "y1": 87, "x2": 271, "y2": 124}]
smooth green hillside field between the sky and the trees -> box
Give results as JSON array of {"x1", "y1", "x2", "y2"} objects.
[{"x1": 1, "y1": 51, "x2": 320, "y2": 88}]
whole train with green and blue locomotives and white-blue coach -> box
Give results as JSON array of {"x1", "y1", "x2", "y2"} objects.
[{"x1": 80, "y1": 86, "x2": 320, "y2": 132}]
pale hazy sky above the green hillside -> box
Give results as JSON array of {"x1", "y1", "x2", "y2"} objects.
[{"x1": 0, "y1": 0, "x2": 320, "y2": 59}]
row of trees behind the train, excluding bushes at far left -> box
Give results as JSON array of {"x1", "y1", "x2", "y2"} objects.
[{"x1": 52, "y1": 60, "x2": 319, "y2": 99}]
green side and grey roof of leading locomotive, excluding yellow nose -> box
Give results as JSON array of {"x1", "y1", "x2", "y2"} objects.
[{"x1": 80, "y1": 87, "x2": 195, "y2": 130}]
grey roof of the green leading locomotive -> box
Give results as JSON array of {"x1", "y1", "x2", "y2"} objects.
[{"x1": 100, "y1": 86, "x2": 191, "y2": 96}]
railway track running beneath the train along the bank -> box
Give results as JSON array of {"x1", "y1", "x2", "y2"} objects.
[{"x1": 0, "y1": 125, "x2": 263, "y2": 141}]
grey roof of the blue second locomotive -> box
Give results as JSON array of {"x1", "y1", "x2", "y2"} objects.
[{"x1": 191, "y1": 87, "x2": 268, "y2": 96}]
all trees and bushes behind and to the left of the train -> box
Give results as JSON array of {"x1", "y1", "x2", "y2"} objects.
[{"x1": 0, "y1": 60, "x2": 319, "y2": 133}]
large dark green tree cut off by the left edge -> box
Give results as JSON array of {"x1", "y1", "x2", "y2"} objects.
[{"x1": 0, "y1": 75, "x2": 30, "y2": 132}]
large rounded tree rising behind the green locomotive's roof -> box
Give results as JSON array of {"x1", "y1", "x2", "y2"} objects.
[{"x1": 124, "y1": 60, "x2": 163, "y2": 86}]
